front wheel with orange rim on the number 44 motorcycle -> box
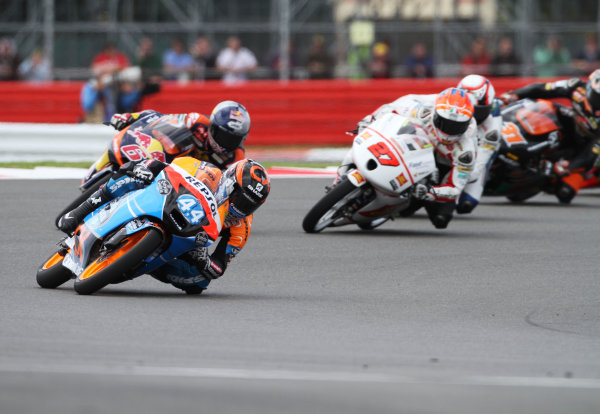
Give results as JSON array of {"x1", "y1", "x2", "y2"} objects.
[{"x1": 74, "y1": 228, "x2": 163, "y2": 295}]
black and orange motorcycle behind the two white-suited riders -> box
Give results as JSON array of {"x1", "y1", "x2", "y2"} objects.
[{"x1": 483, "y1": 99, "x2": 574, "y2": 202}]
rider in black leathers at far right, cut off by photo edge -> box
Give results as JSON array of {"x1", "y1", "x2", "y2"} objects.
[{"x1": 500, "y1": 69, "x2": 600, "y2": 203}]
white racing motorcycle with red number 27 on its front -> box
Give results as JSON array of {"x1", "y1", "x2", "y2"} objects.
[{"x1": 302, "y1": 113, "x2": 437, "y2": 233}]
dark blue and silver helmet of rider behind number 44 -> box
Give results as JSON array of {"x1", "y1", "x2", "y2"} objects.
[{"x1": 208, "y1": 101, "x2": 250, "y2": 154}]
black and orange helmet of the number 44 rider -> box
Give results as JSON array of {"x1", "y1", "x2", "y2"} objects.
[{"x1": 222, "y1": 159, "x2": 271, "y2": 218}]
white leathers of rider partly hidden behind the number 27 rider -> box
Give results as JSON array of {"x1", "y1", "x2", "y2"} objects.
[{"x1": 456, "y1": 99, "x2": 502, "y2": 214}]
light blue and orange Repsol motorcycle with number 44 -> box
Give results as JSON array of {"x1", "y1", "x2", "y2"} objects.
[{"x1": 37, "y1": 164, "x2": 222, "y2": 295}]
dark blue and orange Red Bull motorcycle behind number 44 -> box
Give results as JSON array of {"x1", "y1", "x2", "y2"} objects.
[{"x1": 54, "y1": 115, "x2": 193, "y2": 227}]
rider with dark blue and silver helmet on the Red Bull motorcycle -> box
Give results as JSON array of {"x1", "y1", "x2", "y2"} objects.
[{"x1": 109, "y1": 101, "x2": 250, "y2": 169}]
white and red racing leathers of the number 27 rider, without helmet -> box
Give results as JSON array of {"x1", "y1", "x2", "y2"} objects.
[{"x1": 342, "y1": 94, "x2": 477, "y2": 229}]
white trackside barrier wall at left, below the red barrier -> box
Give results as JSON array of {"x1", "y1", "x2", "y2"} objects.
[{"x1": 0, "y1": 122, "x2": 115, "y2": 162}]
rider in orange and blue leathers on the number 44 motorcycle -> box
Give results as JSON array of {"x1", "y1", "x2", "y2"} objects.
[{"x1": 58, "y1": 157, "x2": 271, "y2": 294}]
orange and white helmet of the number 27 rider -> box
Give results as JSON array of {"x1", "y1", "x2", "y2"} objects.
[{"x1": 433, "y1": 88, "x2": 474, "y2": 144}]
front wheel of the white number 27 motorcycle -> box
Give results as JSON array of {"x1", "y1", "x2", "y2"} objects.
[{"x1": 302, "y1": 180, "x2": 357, "y2": 233}]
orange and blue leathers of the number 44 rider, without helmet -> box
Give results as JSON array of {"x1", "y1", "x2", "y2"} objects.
[{"x1": 59, "y1": 157, "x2": 253, "y2": 294}]
